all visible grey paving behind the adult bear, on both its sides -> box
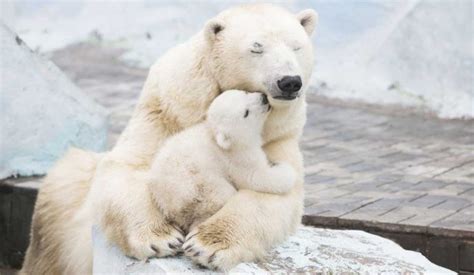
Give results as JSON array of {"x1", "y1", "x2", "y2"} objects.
[{"x1": 51, "y1": 44, "x2": 474, "y2": 234}]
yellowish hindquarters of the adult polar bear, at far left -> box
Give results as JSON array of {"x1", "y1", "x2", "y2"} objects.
[{"x1": 20, "y1": 149, "x2": 102, "y2": 274}]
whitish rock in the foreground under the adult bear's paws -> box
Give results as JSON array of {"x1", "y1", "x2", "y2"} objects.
[{"x1": 92, "y1": 226, "x2": 456, "y2": 274}]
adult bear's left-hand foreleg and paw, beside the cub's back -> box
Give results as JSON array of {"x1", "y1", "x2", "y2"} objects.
[{"x1": 88, "y1": 159, "x2": 184, "y2": 260}]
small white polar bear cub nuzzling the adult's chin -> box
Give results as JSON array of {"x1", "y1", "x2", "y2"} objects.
[{"x1": 149, "y1": 90, "x2": 296, "y2": 230}]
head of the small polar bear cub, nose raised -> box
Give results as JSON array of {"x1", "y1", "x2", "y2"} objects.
[{"x1": 206, "y1": 90, "x2": 271, "y2": 150}]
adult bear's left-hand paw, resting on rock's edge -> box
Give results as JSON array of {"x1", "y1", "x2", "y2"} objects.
[{"x1": 124, "y1": 225, "x2": 184, "y2": 260}]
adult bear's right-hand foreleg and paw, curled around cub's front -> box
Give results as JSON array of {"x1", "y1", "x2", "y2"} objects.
[{"x1": 183, "y1": 139, "x2": 303, "y2": 270}]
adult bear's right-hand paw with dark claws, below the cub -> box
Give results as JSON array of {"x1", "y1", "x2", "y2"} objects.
[{"x1": 183, "y1": 226, "x2": 241, "y2": 271}]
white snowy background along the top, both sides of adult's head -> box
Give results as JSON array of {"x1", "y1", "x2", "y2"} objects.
[{"x1": 2, "y1": 0, "x2": 474, "y2": 118}]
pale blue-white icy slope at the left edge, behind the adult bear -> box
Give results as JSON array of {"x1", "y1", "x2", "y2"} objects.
[{"x1": 0, "y1": 23, "x2": 107, "y2": 178}]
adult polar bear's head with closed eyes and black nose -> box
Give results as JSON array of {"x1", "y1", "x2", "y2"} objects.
[{"x1": 204, "y1": 4, "x2": 318, "y2": 107}]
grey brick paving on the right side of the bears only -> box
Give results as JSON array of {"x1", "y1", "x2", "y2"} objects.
[{"x1": 301, "y1": 98, "x2": 474, "y2": 234}]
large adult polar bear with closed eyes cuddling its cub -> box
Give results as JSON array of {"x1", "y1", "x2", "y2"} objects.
[{"x1": 22, "y1": 4, "x2": 317, "y2": 274}]
